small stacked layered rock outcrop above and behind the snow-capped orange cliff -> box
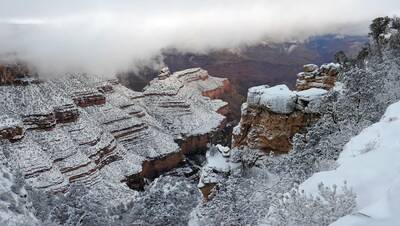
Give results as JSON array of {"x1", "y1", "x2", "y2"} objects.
[{"x1": 296, "y1": 63, "x2": 340, "y2": 91}]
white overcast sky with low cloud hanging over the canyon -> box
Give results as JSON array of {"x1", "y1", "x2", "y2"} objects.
[{"x1": 0, "y1": 0, "x2": 400, "y2": 74}]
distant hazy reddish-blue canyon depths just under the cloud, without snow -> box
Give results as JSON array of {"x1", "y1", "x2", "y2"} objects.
[{"x1": 119, "y1": 35, "x2": 368, "y2": 95}]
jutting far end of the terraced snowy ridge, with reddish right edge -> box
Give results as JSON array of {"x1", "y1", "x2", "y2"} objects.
[{"x1": 137, "y1": 68, "x2": 227, "y2": 151}]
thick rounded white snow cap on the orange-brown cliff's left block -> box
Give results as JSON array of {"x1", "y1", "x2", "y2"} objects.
[{"x1": 260, "y1": 85, "x2": 297, "y2": 114}]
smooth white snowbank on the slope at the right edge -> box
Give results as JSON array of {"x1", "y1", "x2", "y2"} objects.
[{"x1": 300, "y1": 102, "x2": 400, "y2": 226}]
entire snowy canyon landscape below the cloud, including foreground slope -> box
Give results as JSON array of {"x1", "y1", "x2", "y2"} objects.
[{"x1": 0, "y1": 14, "x2": 400, "y2": 226}]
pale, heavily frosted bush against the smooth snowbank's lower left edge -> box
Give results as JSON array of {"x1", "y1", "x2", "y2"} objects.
[{"x1": 266, "y1": 183, "x2": 356, "y2": 226}]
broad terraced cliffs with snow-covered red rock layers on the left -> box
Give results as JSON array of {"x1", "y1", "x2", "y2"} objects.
[{"x1": 0, "y1": 64, "x2": 227, "y2": 202}]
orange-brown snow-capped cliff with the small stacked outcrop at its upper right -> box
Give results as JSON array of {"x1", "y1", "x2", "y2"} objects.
[{"x1": 233, "y1": 64, "x2": 339, "y2": 153}]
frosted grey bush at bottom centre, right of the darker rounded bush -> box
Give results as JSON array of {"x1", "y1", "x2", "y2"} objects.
[{"x1": 191, "y1": 167, "x2": 275, "y2": 226}]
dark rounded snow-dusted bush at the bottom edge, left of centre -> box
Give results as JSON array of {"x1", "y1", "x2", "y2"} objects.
[{"x1": 115, "y1": 176, "x2": 201, "y2": 226}]
